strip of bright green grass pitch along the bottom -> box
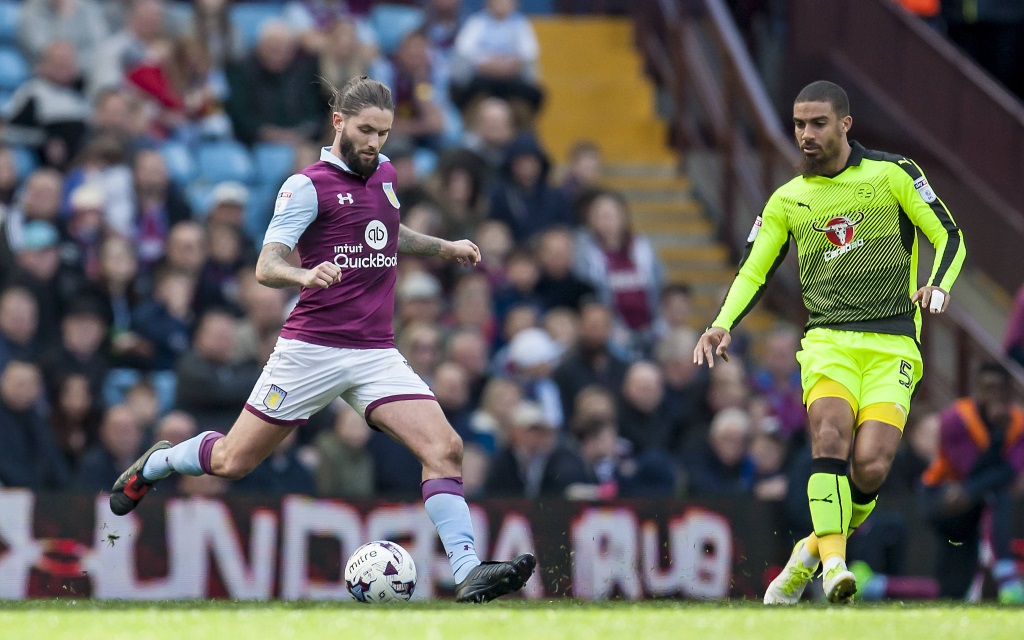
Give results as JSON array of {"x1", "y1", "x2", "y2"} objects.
[{"x1": 0, "y1": 600, "x2": 1024, "y2": 640}]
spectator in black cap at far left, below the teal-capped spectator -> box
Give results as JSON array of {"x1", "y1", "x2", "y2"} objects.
[{"x1": 39, "y1": 294, "x2": 109, "y2": 393}]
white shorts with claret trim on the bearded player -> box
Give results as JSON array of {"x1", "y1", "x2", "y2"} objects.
[{"x1": 246, "y1": 338, "x2": 435, "y2": 426}]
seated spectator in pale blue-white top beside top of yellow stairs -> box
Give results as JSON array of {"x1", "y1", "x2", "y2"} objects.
[{"x1": 453, "y1": 0, "x2": 544, "y2": 119}]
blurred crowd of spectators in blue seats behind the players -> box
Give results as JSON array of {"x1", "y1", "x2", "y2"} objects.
[{"x1": 0, "y1": 0, "x2": 1024, "y2": 598}]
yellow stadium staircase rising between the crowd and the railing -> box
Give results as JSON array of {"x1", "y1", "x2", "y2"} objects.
[{"x1": 532, "y1": 16, "x2": 775, "y2": 332}]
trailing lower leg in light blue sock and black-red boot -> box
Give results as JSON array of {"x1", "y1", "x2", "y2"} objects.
[{"x1": 111, "y1": 431, "x2": 224, "y2": 515}]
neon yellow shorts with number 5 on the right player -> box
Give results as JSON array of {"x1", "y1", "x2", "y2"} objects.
[{"x1": 797, "y1": 329, "x2": 924, "y2": 430}]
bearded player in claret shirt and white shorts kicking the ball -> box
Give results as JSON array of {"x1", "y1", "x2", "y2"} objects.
[{"x1": 111, "y1": 77, "x2": 537, "y2": 602}]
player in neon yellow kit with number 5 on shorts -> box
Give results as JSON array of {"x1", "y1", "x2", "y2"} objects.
[{"x1": 693, "y1": 81, "x2": 966, "y2": 604}]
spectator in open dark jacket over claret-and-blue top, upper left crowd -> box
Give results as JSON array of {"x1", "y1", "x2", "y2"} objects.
[{"x1": 132, "y1": 150, "x2": 191, "y2": 264}]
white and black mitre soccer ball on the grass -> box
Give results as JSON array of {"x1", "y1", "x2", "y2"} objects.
[{"x1": 345, "y1": 540, "x2": 416, "y2": 602}]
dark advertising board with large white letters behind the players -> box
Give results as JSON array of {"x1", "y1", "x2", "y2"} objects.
[{"x1": 0, "y1": 489, "x2": 1007, "y2": 600}]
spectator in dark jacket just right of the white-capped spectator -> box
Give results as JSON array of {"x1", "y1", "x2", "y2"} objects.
[{"x1": 552, "y1": 302, "x2": 629, "y2": 421}]
